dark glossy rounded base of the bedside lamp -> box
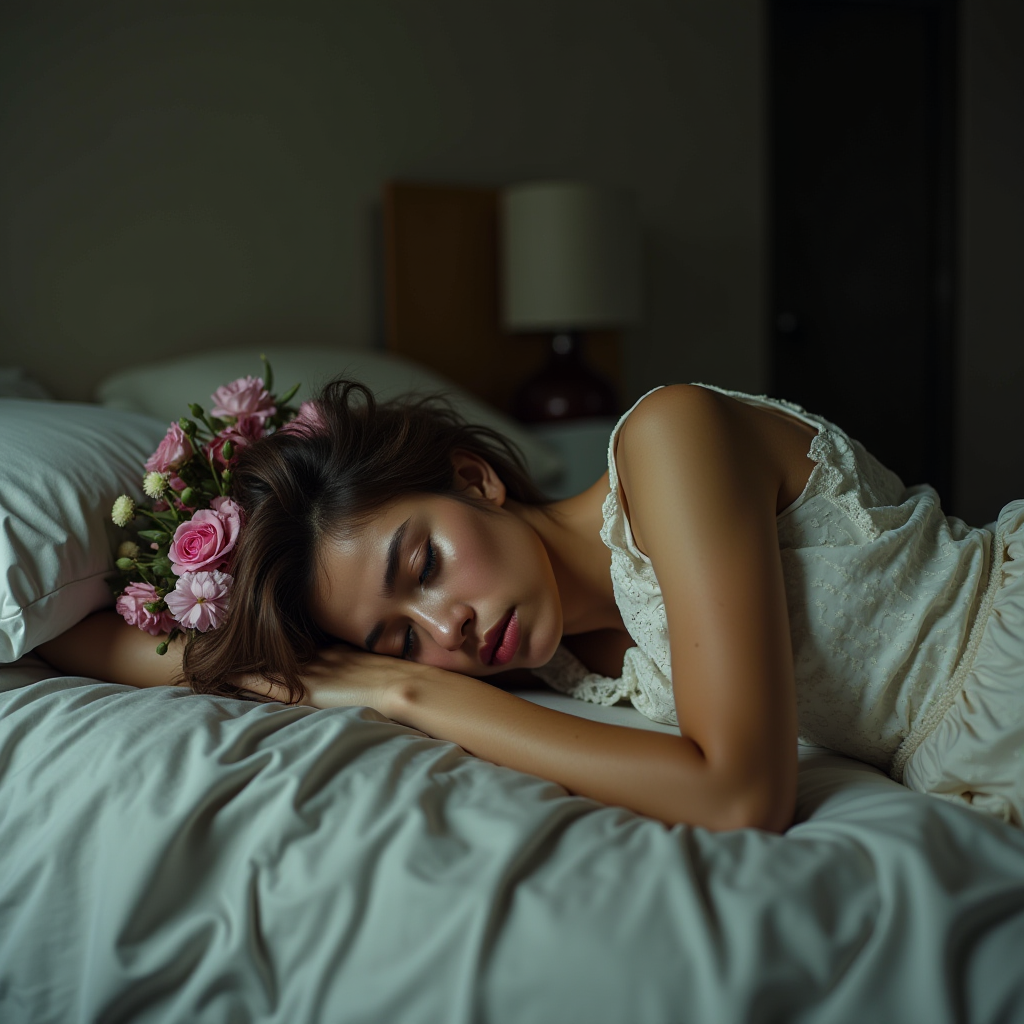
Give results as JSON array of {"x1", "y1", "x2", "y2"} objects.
[{"x1": 512, "y1": 331, "x2": 618, "y2": 423}]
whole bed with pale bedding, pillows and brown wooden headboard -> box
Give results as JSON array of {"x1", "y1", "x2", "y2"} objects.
[{"x1": 0, "y1": 165, "x2": 1024, "y2": 1024}]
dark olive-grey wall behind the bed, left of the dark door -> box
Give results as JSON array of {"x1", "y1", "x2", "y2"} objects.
[{"x1": 0, "y1": 0, "x2": 765, "y2": 398}]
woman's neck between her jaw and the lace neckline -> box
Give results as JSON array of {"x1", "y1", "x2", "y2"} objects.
[{"x1": 506, "y1": 474, "x2": 624, "y2": 636}]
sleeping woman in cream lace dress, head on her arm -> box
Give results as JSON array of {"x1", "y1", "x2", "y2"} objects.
[{"x1": 40, "y1": 381, "x2": 1024, "y2": 831}]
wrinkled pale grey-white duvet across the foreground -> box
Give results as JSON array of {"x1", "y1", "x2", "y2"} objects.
[{"x1": 0, "y1": 657, "x2": 1024, "y2": 1024}]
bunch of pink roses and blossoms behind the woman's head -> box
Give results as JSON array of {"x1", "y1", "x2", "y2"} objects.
[{"x1": 111, "y1": 357, "x2": 303, "y2": 654}]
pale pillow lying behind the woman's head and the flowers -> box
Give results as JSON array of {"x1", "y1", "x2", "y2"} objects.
[{"x1": 96, "y1": 345, "x2": 564, "y2": 486}]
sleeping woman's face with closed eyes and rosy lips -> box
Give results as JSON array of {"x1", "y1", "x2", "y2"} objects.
[{"x1": 311, "y1": 463, "x2": 562, "y2": 676}]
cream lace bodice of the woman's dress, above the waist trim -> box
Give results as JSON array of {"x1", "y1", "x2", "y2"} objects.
[{"x1": 537, "y1": 385, "x2": 1024, "y2": 816}]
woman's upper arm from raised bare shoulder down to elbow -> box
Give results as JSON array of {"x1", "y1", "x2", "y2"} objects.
[{"x1": 617, "y1": 385, "x2": 797, "y2": 826}]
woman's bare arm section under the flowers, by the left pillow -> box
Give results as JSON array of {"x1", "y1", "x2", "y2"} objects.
[{"x1": 36, "y1": 611, "x2": 183, "y2": 686}]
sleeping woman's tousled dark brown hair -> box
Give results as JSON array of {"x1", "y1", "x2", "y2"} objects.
[{"x1": 182, "y1": 380, "x2": 546, "y2": 700}]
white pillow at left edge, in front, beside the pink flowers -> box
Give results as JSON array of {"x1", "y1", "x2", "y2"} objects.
[{"x1": 0, "y1": 398, "x2": 170, "y2": 664}]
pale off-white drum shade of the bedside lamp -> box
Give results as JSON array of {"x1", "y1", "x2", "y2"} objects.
[{"x1": 501, "y1": 181, "x2": 640, "y2": 332}]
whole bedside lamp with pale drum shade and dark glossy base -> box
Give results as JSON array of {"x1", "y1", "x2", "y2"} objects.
[{"x1": 501, "y1": 181, "x2": 640, "y2": 423}]
